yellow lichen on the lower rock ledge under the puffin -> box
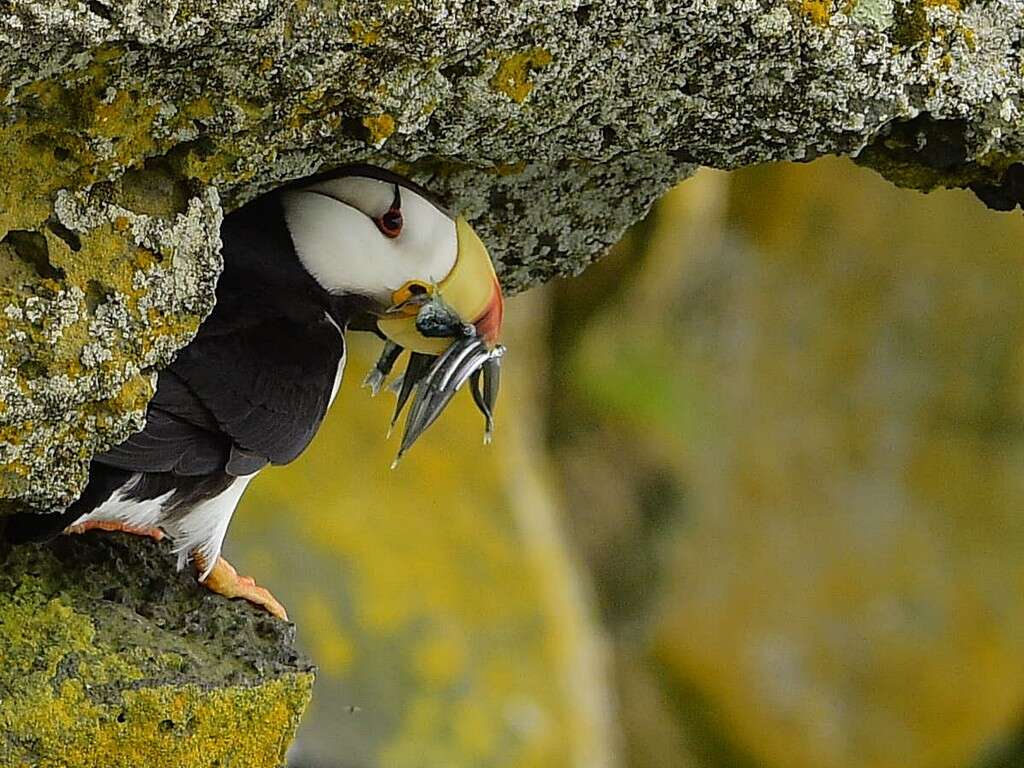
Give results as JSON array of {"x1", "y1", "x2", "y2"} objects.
[{"x1": 0, "y1": 575, "x2": 312, "y2": 768}]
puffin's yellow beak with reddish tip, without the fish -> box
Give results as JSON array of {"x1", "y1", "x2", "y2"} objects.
[{"x1": 377, "y1": 216, "x2": 504, "y2": 354}]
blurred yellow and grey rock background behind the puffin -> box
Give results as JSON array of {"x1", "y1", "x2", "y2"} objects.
[{"x1": 228, "y1": 160, "x2": 1024, "y2": 768}]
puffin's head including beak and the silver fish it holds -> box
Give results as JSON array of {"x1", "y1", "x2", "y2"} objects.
[{"x1": 282, "y1": 166, "x2": 505, "y2": 462}]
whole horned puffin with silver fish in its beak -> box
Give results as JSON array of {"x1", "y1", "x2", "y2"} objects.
[{"x1": 7, "y1": 166, "x2": 504, "y2": 618}]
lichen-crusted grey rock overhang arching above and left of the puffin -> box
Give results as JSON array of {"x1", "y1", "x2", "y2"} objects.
[{"x1": 0, "y1": 0, "x2": 1024, "y2": 509}]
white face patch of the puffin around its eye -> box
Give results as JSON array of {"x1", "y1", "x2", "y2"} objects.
[{"x1": 283, "y1": 176, "x2": 458, "y2": 303}]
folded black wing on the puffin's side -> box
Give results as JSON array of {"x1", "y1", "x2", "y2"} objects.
[{"x1": 95, "y1": 316, "x2": 344, "y2": 475}]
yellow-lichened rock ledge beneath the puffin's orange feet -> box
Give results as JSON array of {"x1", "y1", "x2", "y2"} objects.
[{"x1": 0, "y1": 535, "x2": 312, "y2": 768}]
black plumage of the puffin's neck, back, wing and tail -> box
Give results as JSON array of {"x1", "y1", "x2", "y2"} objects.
[{"x1": 7, "y1": 193, "x2": 360, "y2": 540}]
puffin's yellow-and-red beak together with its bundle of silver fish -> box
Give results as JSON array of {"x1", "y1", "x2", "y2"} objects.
[{"x1": 365, "y1": 217, "x2": 505, "y2": 466}]
